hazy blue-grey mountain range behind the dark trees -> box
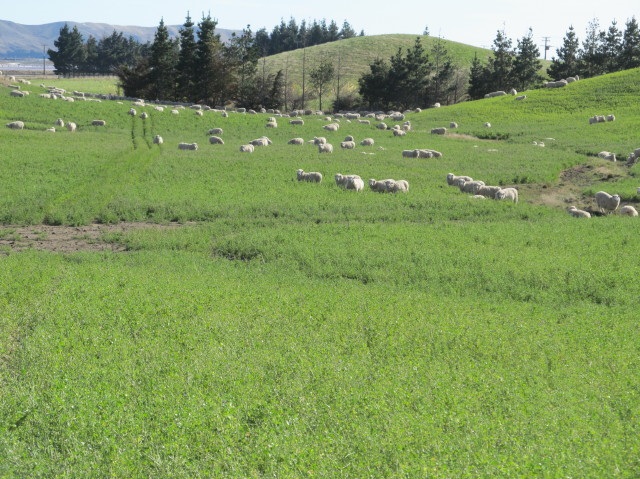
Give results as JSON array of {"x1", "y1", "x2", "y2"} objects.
[{"x1": 0, "y1": 20, "x2": 241, "y2": 59}]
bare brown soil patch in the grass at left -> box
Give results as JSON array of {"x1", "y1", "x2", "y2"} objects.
[{"x1": 0, "y1": 222, "x2": 188, "y2": 254}]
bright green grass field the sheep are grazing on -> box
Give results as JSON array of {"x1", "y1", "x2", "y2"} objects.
[{"x1": 0, "y1": 66, "x2": 640, "y2": 478}]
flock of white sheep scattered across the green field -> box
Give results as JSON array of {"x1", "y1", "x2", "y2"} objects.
[{"x1": 6, "y1": 77, "x2": 640, "y2": 218}]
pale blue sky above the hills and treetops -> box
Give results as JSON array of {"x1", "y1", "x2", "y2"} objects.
[{"x1": 6, "y1": 0, "x2": 640, "y2": 57}]
